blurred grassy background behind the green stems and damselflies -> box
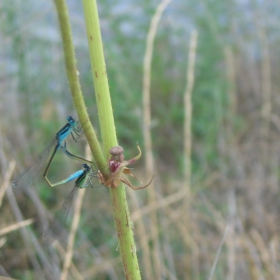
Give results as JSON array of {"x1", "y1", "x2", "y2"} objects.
[{"x1": 0, "y1": 0, "x2": 280, "y2": 280}]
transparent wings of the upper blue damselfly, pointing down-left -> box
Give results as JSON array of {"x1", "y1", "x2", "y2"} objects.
[{"x1": 13, "y1": 138, "x2": 57, "y2": 189}]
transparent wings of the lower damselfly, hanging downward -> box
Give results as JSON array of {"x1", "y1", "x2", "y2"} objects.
[{"x1": 43, "y1": 186, "x2": 78, "y2": 245}]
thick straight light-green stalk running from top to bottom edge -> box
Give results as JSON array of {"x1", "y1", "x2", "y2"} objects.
[{"x1": 83, "y1": 0, "x2": 141, "y2": 280}]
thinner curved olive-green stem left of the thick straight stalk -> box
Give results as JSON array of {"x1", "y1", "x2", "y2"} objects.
[{"x1": 54, "y1": 0, "x2": 108, "y2": 172}]
